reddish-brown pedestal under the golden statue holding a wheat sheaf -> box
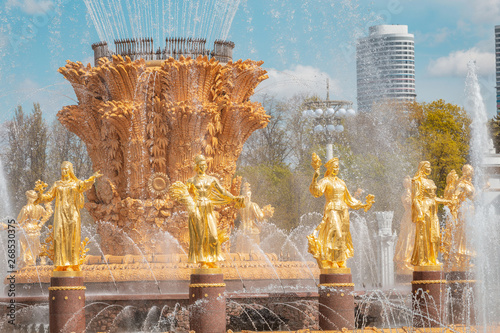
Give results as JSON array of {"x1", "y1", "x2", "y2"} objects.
[{"x1": 189, "y1": 268, "x2": 226, "y2": 333}]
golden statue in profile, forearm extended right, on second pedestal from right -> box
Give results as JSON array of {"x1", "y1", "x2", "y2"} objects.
[{"x1": 411, "y1": 161, "x2": 451, "y2": 266}]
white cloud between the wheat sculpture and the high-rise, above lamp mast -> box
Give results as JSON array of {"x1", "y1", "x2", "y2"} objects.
[{"x1": 256, "y1": 65, "x2": 343, "y2": 99}]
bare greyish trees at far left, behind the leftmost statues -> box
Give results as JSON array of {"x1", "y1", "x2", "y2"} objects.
[{"x1": 2, "y1": 103, "x2": 92, "y2": 212}]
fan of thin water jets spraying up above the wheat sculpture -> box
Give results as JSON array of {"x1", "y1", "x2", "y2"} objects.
[{"x1": 84, "y1": 0, "x2": 240, "y2": 46}]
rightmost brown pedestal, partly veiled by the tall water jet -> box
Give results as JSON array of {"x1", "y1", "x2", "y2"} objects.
[{"x1": 446, "y1": 272, "x2": 476, "y2": 326}]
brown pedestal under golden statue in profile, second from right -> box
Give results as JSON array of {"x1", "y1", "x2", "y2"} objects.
[{"x1": 412, "y1": 266, "x2": 446, "y2": 327}]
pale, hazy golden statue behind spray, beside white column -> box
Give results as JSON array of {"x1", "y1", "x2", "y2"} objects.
[{"x1": 394, "y1": 176, "x2": 415, "y2": 275}]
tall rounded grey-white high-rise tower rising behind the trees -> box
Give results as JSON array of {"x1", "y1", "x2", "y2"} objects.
[{"x1": 356, "y1": 25, "x2": 417, "y2": 111}]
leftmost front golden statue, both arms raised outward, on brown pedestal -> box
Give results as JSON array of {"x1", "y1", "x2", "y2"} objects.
[{"x1": 35, "y1": 161, "x2": 102, "y2": 271}]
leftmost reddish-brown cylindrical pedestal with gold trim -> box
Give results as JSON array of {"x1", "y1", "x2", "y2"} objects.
[{"x1": 49, "y1": 272, "x2": 85, "y2": 333}]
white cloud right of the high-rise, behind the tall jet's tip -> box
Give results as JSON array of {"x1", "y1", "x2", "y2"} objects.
[{"x1": 427, "y1": 47, "x2": 495, "y2": 77}]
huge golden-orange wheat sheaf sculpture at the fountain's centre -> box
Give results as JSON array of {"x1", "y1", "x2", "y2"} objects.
[{"x1": 58, "y1": 56, "x2": 269, "y2": 255}]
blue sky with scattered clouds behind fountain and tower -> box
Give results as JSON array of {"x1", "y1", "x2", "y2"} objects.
[{"x1": 0, "y1": 0, "x2": 500, "y2": 122}]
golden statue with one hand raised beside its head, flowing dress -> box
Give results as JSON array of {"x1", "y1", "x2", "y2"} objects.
[{"x1": 307, "y1": 153, "x2": 375, "y2": 269}]
